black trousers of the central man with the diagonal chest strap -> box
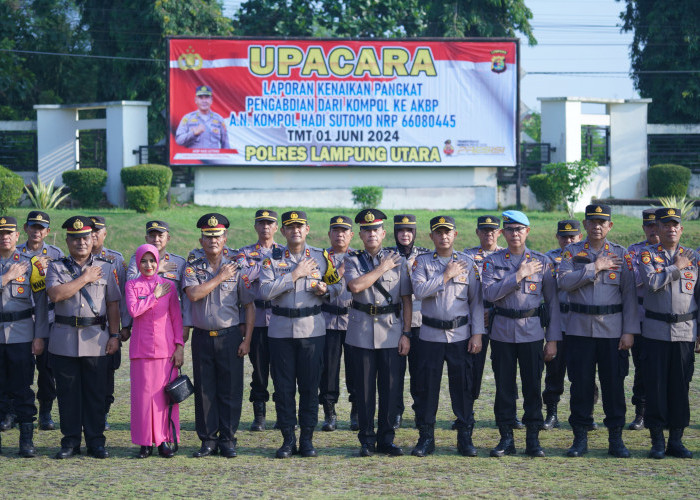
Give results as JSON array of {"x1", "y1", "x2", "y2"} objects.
[{"x1": 347, "y1": 346, "x2": 403, "y2": 446}]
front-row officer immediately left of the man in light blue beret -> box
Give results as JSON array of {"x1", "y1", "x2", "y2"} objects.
[{"x1": 411, "y1": 215, "x2": 484, "y2": 457}]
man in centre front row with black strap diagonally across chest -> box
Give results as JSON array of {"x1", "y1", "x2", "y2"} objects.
[{"x1": 345, "y1": 208, "x2": 413, "y2": 457}]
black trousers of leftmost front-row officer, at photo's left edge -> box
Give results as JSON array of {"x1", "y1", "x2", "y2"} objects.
[{"x1": 0, "y1": 342, "x2": 36, "y2": 424}]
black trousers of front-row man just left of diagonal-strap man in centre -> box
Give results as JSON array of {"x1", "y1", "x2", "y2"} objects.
[{"x1": 268, "y1": 335, "x2": 326, "y2": 429}]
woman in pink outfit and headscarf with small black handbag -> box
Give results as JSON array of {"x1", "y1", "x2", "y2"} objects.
[{"x1": 125, "y1": 245, "x2": 184, "y2": 458}]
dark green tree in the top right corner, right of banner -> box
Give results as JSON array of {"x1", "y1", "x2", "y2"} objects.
[{"x1": 618, "y1": 0, "x2": 700, "y2": 123}]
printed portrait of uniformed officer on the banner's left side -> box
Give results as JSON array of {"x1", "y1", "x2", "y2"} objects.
[{"x1": 175, "y1": 85, "x2": 229, "y2": 149}]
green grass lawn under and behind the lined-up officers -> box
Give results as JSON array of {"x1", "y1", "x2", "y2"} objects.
[{"x1": 0, "y1": 207, "x2": 700, "y2": 498}]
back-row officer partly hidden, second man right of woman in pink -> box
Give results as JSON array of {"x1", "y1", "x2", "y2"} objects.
[{"x1": 237, "y1": 209, "x2": 282, "y2": 431}]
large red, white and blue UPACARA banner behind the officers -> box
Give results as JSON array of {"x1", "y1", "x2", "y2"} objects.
[{"x1": 168, "y1": 38, "x2": 518, "y2": 166}]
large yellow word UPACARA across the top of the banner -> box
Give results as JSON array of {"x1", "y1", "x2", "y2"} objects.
[{"x1": 248, "y1": 45, "x2": 437, "y2": 78}]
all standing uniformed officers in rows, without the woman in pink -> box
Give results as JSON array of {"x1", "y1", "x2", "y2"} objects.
[{"x1": 0, "y1": 204, "x2": 700, "y2": 459}]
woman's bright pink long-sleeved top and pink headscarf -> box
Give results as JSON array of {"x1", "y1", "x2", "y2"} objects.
[{"x1": 125, "y1": 245, "x2": 184, "y2": 359}]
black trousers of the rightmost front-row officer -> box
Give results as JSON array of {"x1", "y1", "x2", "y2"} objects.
[{"x1": 635, "y1": 338, "x2": 695, "y2": 429}]
